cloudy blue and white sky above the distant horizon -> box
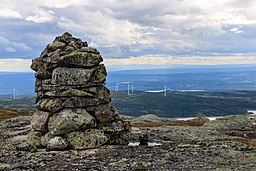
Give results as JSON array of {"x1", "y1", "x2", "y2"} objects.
[{"x1": 0, "y1": 0, "x2": 256, "y2": 72}]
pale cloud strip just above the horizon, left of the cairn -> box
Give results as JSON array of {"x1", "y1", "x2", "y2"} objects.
[{"x1": 0, "y1": 59, "x2": 31, "y2": 72}]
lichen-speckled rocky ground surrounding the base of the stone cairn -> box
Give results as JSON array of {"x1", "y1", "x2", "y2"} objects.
[{"x1": 0, "y1": 110, "x2": 256, "y2": 171}]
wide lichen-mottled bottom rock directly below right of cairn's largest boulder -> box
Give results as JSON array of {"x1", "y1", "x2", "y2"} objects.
[{"x1": 66, "y1": 129, "x2": 108, "y2": 150}]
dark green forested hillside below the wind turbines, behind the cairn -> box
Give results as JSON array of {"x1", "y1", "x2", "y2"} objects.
[{"x1": 0, "y1": 91, "x2": 256, "y2": 117}]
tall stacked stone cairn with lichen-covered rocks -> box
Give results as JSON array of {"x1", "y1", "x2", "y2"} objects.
[{"x1": 26, "y1": 33, "x2": 130, "y2": 150}]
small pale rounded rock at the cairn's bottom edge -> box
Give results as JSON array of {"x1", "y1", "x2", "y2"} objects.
[{"x1": 46, "y1": 136, "x2": 68, "y2": 150}]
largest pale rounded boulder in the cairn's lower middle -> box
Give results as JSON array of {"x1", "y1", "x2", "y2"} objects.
[{"x1": 48, "y1": 108, "x2": 96, "y2": 135}]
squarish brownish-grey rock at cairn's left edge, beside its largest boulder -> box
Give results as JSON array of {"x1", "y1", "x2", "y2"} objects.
[{"x1": 31, "y1": 110, "x2": 50, "y2": 131}]
